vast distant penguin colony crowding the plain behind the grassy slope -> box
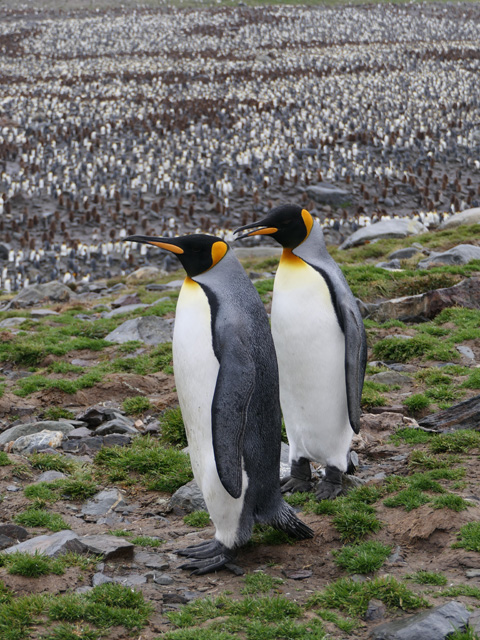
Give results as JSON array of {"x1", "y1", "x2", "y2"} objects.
[{"x1": 0, "y1": 3, "x2": 480, "y2": 291}]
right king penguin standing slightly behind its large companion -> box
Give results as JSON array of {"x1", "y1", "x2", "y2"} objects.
[{"x1": 236, "y1": 205, "x2": 367, "y2": 500}]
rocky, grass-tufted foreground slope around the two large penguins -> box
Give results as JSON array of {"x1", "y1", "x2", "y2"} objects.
[{"x1": 0, "y1": 216, "x2": 480, "y2": 640}]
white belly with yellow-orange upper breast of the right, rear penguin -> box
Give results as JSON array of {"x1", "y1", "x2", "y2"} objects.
[{"x1": 271, "y1": 251, "x2": 353, "y2": 471}]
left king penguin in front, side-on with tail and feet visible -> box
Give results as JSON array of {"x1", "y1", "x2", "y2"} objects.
[{"x1": 126, "y1": 234, "x2": 313, "y2": 574}]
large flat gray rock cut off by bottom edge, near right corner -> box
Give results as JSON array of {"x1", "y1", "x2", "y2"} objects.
[{"x1": 371, "y1": 600, "x2": 470, "y2": 640}]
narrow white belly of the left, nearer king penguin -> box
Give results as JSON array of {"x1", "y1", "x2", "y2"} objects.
[{"x1": 172, "y1": 278, "x2": 248, "y2": 548}]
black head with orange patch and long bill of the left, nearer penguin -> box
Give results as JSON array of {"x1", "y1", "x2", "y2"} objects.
[{"x1": 125, "y1": 233, "x2": 228, "y2": 278}]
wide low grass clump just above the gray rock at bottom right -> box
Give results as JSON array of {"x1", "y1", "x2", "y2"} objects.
[{"x1": 307, "y1": 577, "x2": 430, "y2": 616}]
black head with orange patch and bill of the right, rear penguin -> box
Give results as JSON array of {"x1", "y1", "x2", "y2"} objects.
[{"x1": 235, "y1": 204, "x2": 313, "y2": 249}]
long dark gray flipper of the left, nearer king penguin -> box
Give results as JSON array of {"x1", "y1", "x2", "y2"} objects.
[{"x1": 212, "y1": 335, "x2": 255, "y2": 498}]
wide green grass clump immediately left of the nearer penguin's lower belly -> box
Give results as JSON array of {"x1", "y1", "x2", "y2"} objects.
[{"x1": 95, "y1": 436, "x2": 193, "y2": 493}]
